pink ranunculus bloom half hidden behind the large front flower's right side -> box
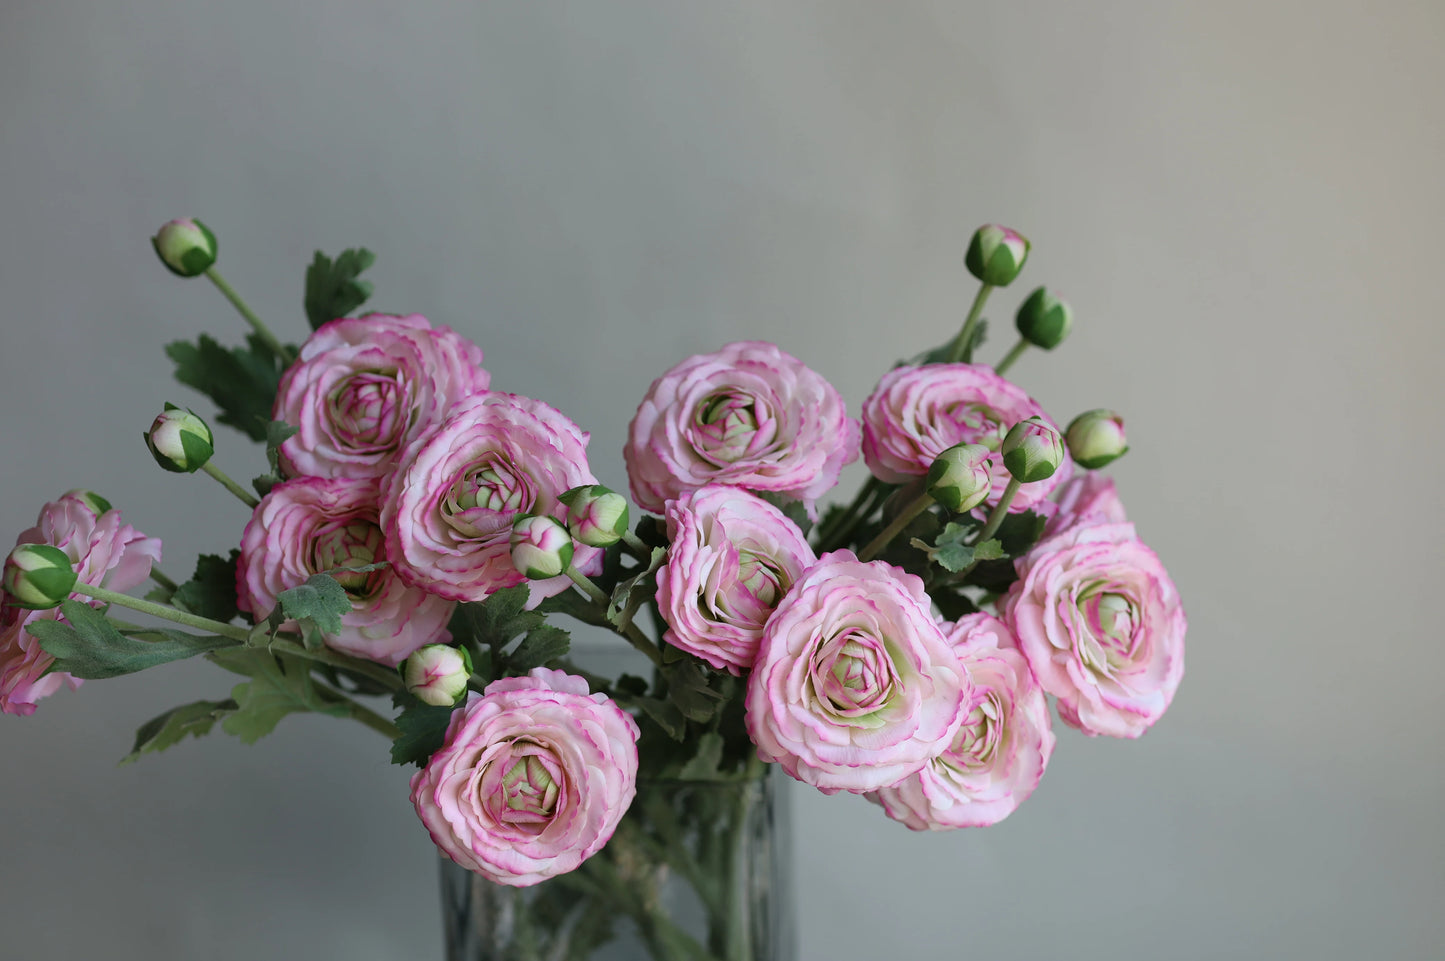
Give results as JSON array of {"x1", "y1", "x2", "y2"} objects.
[{"x1": 868, "y1": 613, "x2": 1055, "y2": 831}]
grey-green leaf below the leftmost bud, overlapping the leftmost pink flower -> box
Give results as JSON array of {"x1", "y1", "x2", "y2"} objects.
[{"x1": 26, "y1": 601, "x2": 236, "y2": 681}]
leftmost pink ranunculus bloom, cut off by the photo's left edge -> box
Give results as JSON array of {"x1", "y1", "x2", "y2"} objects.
[{"x1": 0, "y1": 490, "x2": 160, "y2": 714}]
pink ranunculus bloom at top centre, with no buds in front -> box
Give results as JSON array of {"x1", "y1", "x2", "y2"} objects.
[{"x1": 623, "y1": 341, "x2": 858, "y2": 516}]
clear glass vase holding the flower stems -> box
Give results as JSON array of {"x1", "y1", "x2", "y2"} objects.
[{"x1": 442, "y1": 775, "x2": 796, "y2": 961}]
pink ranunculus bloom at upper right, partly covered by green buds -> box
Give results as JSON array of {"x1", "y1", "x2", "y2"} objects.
[{"x1": 863, "y1": 364, "x2": 1074, "y2": 513}]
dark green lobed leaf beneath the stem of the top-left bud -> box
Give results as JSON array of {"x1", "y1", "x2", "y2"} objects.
[{"x1": 166, "y1": 334, "x2": 282, "y2": 441}]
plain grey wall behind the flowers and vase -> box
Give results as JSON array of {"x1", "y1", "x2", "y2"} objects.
[{"x1": 0, "y1": 0, "x2": 1445, "y2": 961}]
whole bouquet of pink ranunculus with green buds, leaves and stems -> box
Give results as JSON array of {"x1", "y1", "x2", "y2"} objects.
[{"x1": 0, "y1": 220, "x2": 1185, "y2": 958}]
